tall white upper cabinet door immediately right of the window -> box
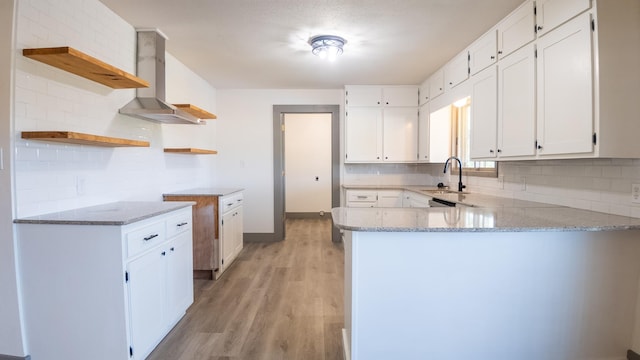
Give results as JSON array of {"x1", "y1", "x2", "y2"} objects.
[{"x1": 470, "y1": 66, "x2": 498, "y2": 159}]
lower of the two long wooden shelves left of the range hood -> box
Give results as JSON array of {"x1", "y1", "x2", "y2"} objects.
[{"x1": 22, "y1": 131, "x2": 149, "y2": 147}]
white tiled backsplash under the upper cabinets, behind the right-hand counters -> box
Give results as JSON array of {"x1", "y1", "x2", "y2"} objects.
[{"x1": 343, "y1": 159, "x2": 640, "y2": 218}]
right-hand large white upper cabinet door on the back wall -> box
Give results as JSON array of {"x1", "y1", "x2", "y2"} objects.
[{"x1": 383, "y1": 107, "x2": 418, "y2": 162}]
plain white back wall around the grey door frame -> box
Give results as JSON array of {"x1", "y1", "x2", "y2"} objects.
[{"x1": 214, "y1": 89, "x2": 344, "y2": 233}]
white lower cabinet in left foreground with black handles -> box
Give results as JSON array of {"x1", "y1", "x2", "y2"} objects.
[{"x1": 17, "y1": 206, "x2": 193, "y2": 360}]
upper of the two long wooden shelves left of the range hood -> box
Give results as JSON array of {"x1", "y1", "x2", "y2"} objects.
[{"x1": 22, "y1": 46, "x2": 149, "y2": 89}]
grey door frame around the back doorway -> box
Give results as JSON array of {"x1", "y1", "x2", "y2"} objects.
[{"x1": 273, "y1": 105, "x2": 341, "y2": 242}]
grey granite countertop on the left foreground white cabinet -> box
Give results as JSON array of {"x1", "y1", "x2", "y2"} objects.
[{"x1": 13, "y1": 201, "x2": 195, "y2": 225}]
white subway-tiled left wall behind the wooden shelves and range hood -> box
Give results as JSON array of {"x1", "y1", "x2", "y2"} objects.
[{"x1": 14, "y1": 0, "x2": 215, "y2": 217}]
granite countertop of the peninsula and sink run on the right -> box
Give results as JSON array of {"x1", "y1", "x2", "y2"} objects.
[{"x1": 338, "y1": 185, "x2": 640, "y2": 232}]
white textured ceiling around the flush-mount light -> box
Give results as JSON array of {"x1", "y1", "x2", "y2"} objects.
[{"x1": 101, "y1": 0, "x2": 523, "y2": 89}]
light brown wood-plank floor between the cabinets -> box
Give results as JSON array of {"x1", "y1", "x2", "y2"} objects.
[{"x1": 148, "y1": 219, "x2": 344, "y2": 360}]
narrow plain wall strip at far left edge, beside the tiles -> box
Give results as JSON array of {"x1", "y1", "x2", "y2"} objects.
[{"x1": 0, "y1": 0, "x2": 26, "y2": 356}]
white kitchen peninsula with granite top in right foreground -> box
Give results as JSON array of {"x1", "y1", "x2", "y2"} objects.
[{"x1": 332, "y1": 200, "x2": 640, "y2": 360}]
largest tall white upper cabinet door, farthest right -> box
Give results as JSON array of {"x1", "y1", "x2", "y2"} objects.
[{"x1": 538, "y1": 13, "x2": 593, "y2": 155}]
